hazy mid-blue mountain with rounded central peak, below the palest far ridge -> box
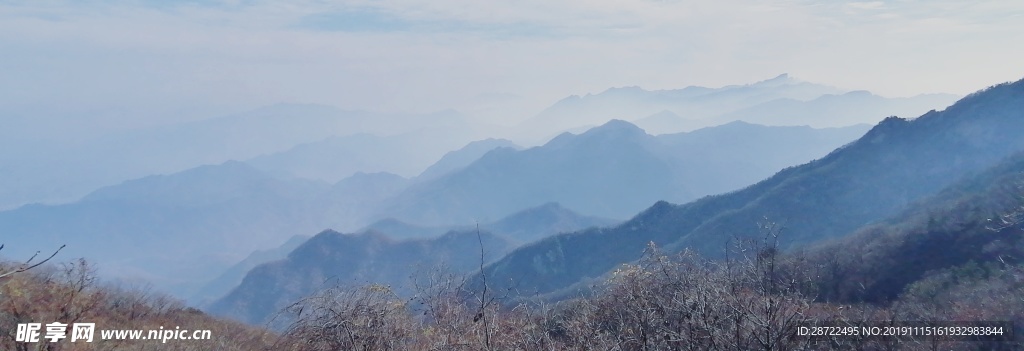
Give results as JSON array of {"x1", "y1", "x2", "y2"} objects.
[{"x1": 379, "y1": 120, "x2": 868, "y2": 225}]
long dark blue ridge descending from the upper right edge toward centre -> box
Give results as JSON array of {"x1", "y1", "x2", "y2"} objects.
[{"x1": 468, "y1": 81, "x2": 1024, "y2": 296}]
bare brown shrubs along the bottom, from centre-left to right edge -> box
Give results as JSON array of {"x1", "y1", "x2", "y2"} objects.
[{"x1": 275, "y1": 225, "x2": 1024, "y2": 350}]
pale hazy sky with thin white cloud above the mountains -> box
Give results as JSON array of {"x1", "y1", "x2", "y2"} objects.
[{"x1": 0, "y1": 0, "x2": 1024, "y2": 127}]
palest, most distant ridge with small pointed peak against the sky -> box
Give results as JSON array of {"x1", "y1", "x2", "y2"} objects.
[{"x1": 518, "y1": 74, "x2": 957, "y2": 139}]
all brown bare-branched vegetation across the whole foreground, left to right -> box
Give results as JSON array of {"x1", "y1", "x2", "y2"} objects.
[{"x1": 0, "y1": 224, "x2": 1024, "y2": 351}]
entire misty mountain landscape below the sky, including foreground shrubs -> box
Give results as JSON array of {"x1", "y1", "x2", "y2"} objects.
[{"x1": 0, "y1": 75, "x2": 1024, "y2": 350}]
